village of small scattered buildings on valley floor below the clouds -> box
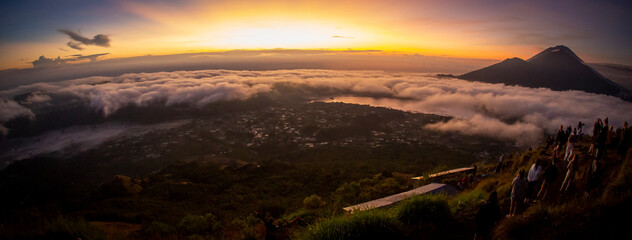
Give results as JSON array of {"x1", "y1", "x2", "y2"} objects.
[{"x1": 95, "y1": 102, "x2": 501, "y2": 164}]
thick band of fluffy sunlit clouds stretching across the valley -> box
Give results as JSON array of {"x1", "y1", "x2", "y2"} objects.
[{"x1": 0, "y1": 69, "x2": 632, "y2": 145}]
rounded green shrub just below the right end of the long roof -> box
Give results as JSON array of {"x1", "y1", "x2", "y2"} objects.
[{"x1": 395, "y1": 194, "x2": 452, "y2": 224}]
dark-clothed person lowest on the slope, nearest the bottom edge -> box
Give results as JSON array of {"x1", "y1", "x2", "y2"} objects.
[{"x1": 474, "y1": 191, "x2": 502, "y2": 240}]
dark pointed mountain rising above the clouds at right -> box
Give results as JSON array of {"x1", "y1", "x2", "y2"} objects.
[{"x1": 457, "y1": 45, "x2": 632, "y2": 101}]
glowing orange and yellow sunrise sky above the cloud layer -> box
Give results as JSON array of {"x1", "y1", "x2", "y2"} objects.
[{"x1": 0, "y1": 0, "x2": 629, "y2": 69}]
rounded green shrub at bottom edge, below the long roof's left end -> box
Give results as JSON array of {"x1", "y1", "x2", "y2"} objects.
[{"x1": 301, "y1": 210, "x2": 402, "y2": 240}]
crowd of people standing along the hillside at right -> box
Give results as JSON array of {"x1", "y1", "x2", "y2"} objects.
[{"x1": 475, "y1": 118, "x2": 632, "y2": 239}]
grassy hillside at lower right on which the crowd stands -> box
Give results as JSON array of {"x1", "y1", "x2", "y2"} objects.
[{"x1": 298, "y1": 140, "x2": 632, "y2": 239}]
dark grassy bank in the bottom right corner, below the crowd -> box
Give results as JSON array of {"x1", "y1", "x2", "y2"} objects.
[{"x1": 496, "y1": 149, "x2": 632, "y2": 239}]
